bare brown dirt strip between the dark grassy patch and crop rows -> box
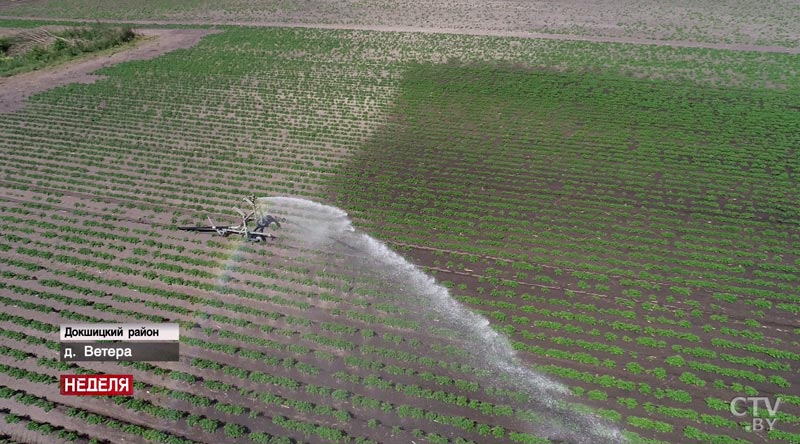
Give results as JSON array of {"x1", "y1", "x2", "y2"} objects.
[{"x1": 0, "y1": 29, "x2": 214, "y2": 114}]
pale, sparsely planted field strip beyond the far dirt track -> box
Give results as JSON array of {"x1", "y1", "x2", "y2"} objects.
[{"x1": 0, "y1": 0, "x2": 800, "y2": 49}]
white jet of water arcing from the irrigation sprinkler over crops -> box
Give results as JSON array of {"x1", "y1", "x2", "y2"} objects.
[{"x1": 258, "y1": 197, "x2": 624, "y2": 444}]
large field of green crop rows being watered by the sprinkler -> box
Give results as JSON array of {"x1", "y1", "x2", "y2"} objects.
[{"x1": 0, "y1": 10, "x2": 800, "y2": 443}]
